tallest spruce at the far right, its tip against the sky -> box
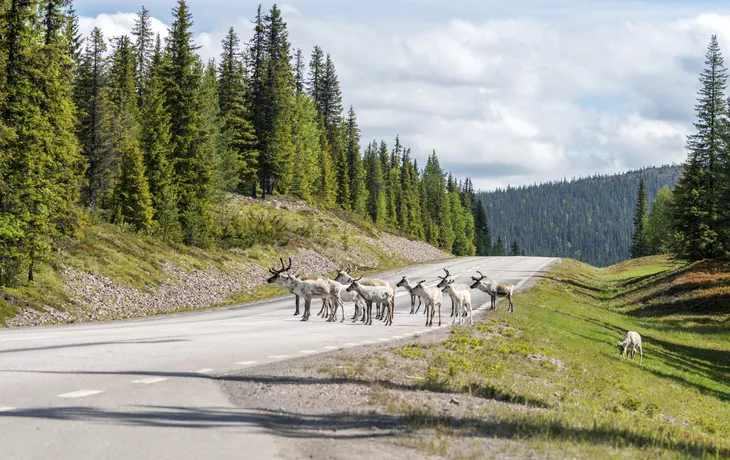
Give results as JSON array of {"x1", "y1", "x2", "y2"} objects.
[{"x1": 674, "y1": 35, "x2": 728, "y2": 260}]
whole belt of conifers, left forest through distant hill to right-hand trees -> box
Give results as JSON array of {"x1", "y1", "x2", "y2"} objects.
[{"x1": 0, "y1": 0, "x2": 730, "y2": 286}]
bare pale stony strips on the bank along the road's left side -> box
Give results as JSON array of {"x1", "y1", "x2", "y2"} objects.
[{"x1": 6, "y1": 226, "x2": 451, "y2": 327}]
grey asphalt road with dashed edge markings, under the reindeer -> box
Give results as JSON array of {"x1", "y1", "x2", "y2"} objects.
[{"x1": 0, "y1": 257, "x2": 555, "y2": 460}]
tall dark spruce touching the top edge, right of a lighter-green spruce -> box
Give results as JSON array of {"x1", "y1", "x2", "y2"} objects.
[{"x1": 164, "y1": 0, "x2": 213, "y2": 246}]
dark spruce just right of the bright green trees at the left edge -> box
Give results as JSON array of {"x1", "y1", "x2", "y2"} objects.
[{"x1": 74, "y1": 27, "x2": 114, "y2": 211}]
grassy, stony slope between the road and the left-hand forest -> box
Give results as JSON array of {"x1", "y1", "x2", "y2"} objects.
[{"x1": 0, "y1": 197, "x2": 451, "y2": 327}]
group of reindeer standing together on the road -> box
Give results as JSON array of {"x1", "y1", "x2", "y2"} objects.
[{"x1": 266, "y1": 257, "x2": 515, "y2": 327}]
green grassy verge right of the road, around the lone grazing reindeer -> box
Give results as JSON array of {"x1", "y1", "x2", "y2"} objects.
[{"x1": 372, "y1": 257, "x2": 730, "y2": 458}]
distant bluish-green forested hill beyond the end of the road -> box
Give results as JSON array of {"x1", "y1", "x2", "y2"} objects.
[{"x1": 478, "y1": 166, "x2": 681, "y2": 267}]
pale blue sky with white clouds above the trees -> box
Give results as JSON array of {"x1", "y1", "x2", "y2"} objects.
[{"x1": 74, "y1": 0, "x2": 730, "y2": 190}]
